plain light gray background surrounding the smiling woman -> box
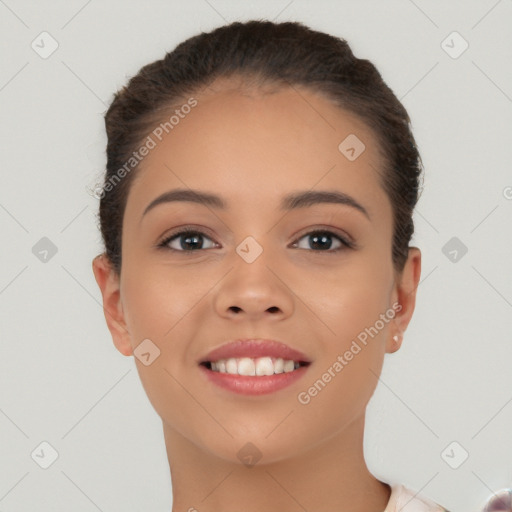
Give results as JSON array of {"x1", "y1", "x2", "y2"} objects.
[{"x1": 0, "y1": 0, "x2": 512, "y2": 512}]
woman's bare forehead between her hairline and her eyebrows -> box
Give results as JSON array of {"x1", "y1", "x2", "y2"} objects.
[{"x1": 122, "y1": 79, "x2": 389, "y2": 222}]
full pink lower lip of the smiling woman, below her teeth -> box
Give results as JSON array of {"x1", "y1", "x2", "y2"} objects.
[{"x1": 199, "y1": 364, "x2": 311, "y2": 395}]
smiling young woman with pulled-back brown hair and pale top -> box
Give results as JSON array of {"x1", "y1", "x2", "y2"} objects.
[{"x1": 93, "y1": 21, "x2": 450, "y2": 512}]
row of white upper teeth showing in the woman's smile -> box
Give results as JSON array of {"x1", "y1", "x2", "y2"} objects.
[{"x1": 210, "y1": 357, "x2": 300, "y2": 376}]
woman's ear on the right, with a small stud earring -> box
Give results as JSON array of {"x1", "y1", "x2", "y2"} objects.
[{"x1": 386, "y1": 247, "x2": 421, "y2": 353}]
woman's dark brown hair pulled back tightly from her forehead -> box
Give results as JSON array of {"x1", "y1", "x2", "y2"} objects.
[{"x1": 99, "y1": 20, "x2": 422, "y2": 275}]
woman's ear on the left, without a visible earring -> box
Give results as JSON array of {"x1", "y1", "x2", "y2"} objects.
[{"x1": 92, "y1": 254, "x2": 133, "y2": 356}]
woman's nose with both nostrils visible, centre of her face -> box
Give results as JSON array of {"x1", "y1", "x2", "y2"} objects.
[{"x1": 214, "y1": 251, "x2": 294, "y2": 321}]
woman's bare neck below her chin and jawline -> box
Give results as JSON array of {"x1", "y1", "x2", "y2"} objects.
[{"x1": 164, "y1": 416, "x2": 391, "y2": 512}]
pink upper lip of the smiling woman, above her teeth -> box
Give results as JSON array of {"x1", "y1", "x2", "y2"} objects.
[{"x1": 199, "y1": 338, "x2": 311, "y2": 364}]
